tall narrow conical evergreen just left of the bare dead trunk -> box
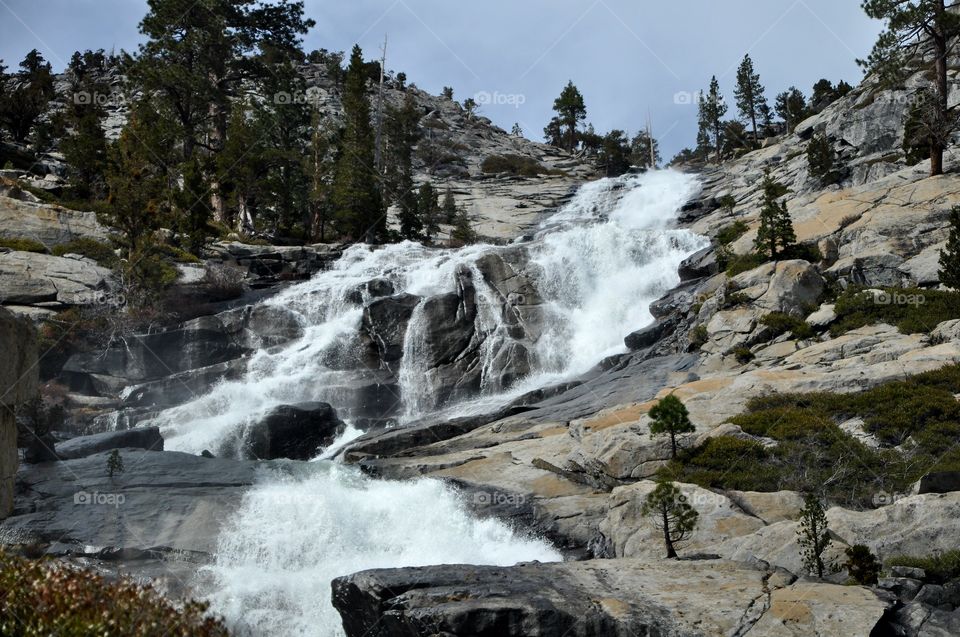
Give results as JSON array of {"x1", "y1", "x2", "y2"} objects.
[{"x1": 333, "y1": 45, "x2": 386, "y2": 243}]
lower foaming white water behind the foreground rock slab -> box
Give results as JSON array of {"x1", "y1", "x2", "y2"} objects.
[{"x1": 202, "y1": 463, "x2": 560, "y2": 637}]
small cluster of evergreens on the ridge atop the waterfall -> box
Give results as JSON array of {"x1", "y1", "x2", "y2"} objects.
[{"x1": 540, "y1": 81, "x2": 661, "y2": 177}]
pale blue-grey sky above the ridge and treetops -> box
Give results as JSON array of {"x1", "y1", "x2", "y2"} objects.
[{"x1": 0, "y1": 0, "x2": 882, "y2": 159}]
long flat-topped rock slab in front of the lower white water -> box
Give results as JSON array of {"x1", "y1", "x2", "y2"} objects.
[{"x1": 332, "y1": 560, "x2": 886, "y2": 637}]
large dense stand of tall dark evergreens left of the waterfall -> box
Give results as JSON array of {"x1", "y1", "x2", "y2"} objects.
[{"x1": 0, "y1": 0, "x2": 475, "y2": 290}]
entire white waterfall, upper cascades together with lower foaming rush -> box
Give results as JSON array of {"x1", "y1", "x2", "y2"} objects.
[{"x1": 150, "y1": 171, "x2": 706, "y2": 635}]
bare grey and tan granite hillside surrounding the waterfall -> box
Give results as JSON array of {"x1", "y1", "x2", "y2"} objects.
[{"x1": 0, "y1": 38, "x2": 960, "y2": 637}]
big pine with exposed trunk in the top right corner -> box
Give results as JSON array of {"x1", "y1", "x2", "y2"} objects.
[{"x1": 857, "y1": 0, "x2": 960, "y2": 175}]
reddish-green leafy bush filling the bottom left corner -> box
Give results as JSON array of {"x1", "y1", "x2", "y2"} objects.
[{"x1": 0, "y1": 551, "x2": 229, "y2": 637}]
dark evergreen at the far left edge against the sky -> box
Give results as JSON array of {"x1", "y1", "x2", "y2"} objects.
[{"x1": 0, "y1": 49, "x2": 54, "y2": 142}]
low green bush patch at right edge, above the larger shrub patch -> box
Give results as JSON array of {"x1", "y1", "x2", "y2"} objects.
[{"x1": 830, "y1": 288, "x2": 960, "y2": 336}]
